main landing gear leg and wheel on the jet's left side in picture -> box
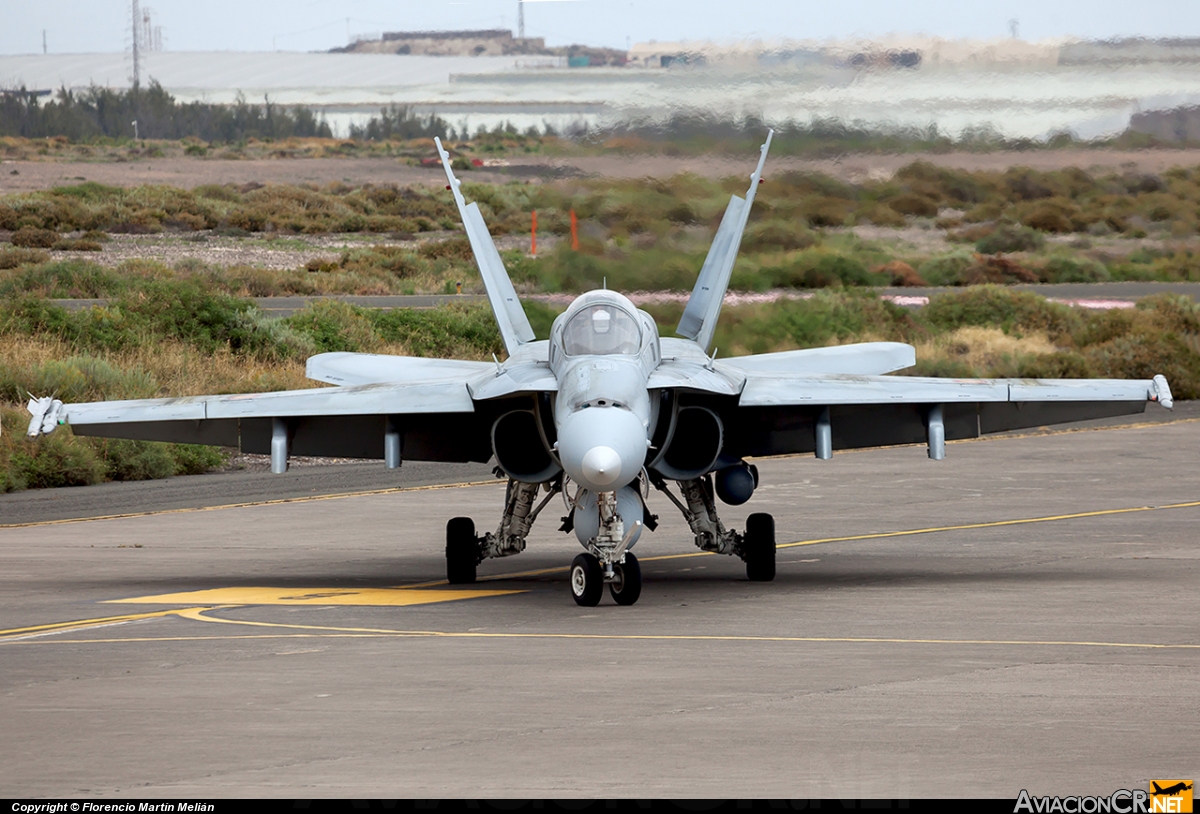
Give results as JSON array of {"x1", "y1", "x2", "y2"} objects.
[{"x1": 446, "y1": 478, "x2": 563, "y2": 585}]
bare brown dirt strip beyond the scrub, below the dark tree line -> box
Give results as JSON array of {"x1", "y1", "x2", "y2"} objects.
[{"x1": 0, "y1": 150, "x2": 1200, "y2": 193}]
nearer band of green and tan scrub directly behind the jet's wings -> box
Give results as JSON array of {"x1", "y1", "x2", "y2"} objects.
[{"x1": 0, "y1": 281, "x2": 1200, "y2": 491}]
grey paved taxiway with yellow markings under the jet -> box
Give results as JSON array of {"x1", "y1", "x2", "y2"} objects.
[{"x1": 0, "y1": 408, "x2": 1200, "y2": 800}]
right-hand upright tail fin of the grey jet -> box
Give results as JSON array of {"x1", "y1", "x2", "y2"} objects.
[{"x1": 676, "y1": 130, "x2": 775, "y2": 351}]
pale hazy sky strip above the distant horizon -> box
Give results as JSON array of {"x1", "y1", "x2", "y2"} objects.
[{"x1": 0, "y1": 0, "x2": 1200, "y2": 54}]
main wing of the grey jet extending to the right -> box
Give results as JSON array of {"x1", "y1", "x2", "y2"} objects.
[{"x1": 713, "y1": 371, "x2": 1172, "y2": 456}]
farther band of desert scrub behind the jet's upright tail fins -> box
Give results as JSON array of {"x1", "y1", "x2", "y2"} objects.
[{"x1": 7, "y1": 162, "x2": 1200, "y2": 297}]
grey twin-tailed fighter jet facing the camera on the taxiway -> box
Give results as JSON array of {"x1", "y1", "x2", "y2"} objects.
[{"x1": 29, "y1": 133, "x2": 1171, "y2": 606}]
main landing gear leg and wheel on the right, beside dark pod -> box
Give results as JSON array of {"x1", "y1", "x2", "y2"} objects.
[{"x1": 650, "y1": 474, "x2": 775, "y2": 582}]
